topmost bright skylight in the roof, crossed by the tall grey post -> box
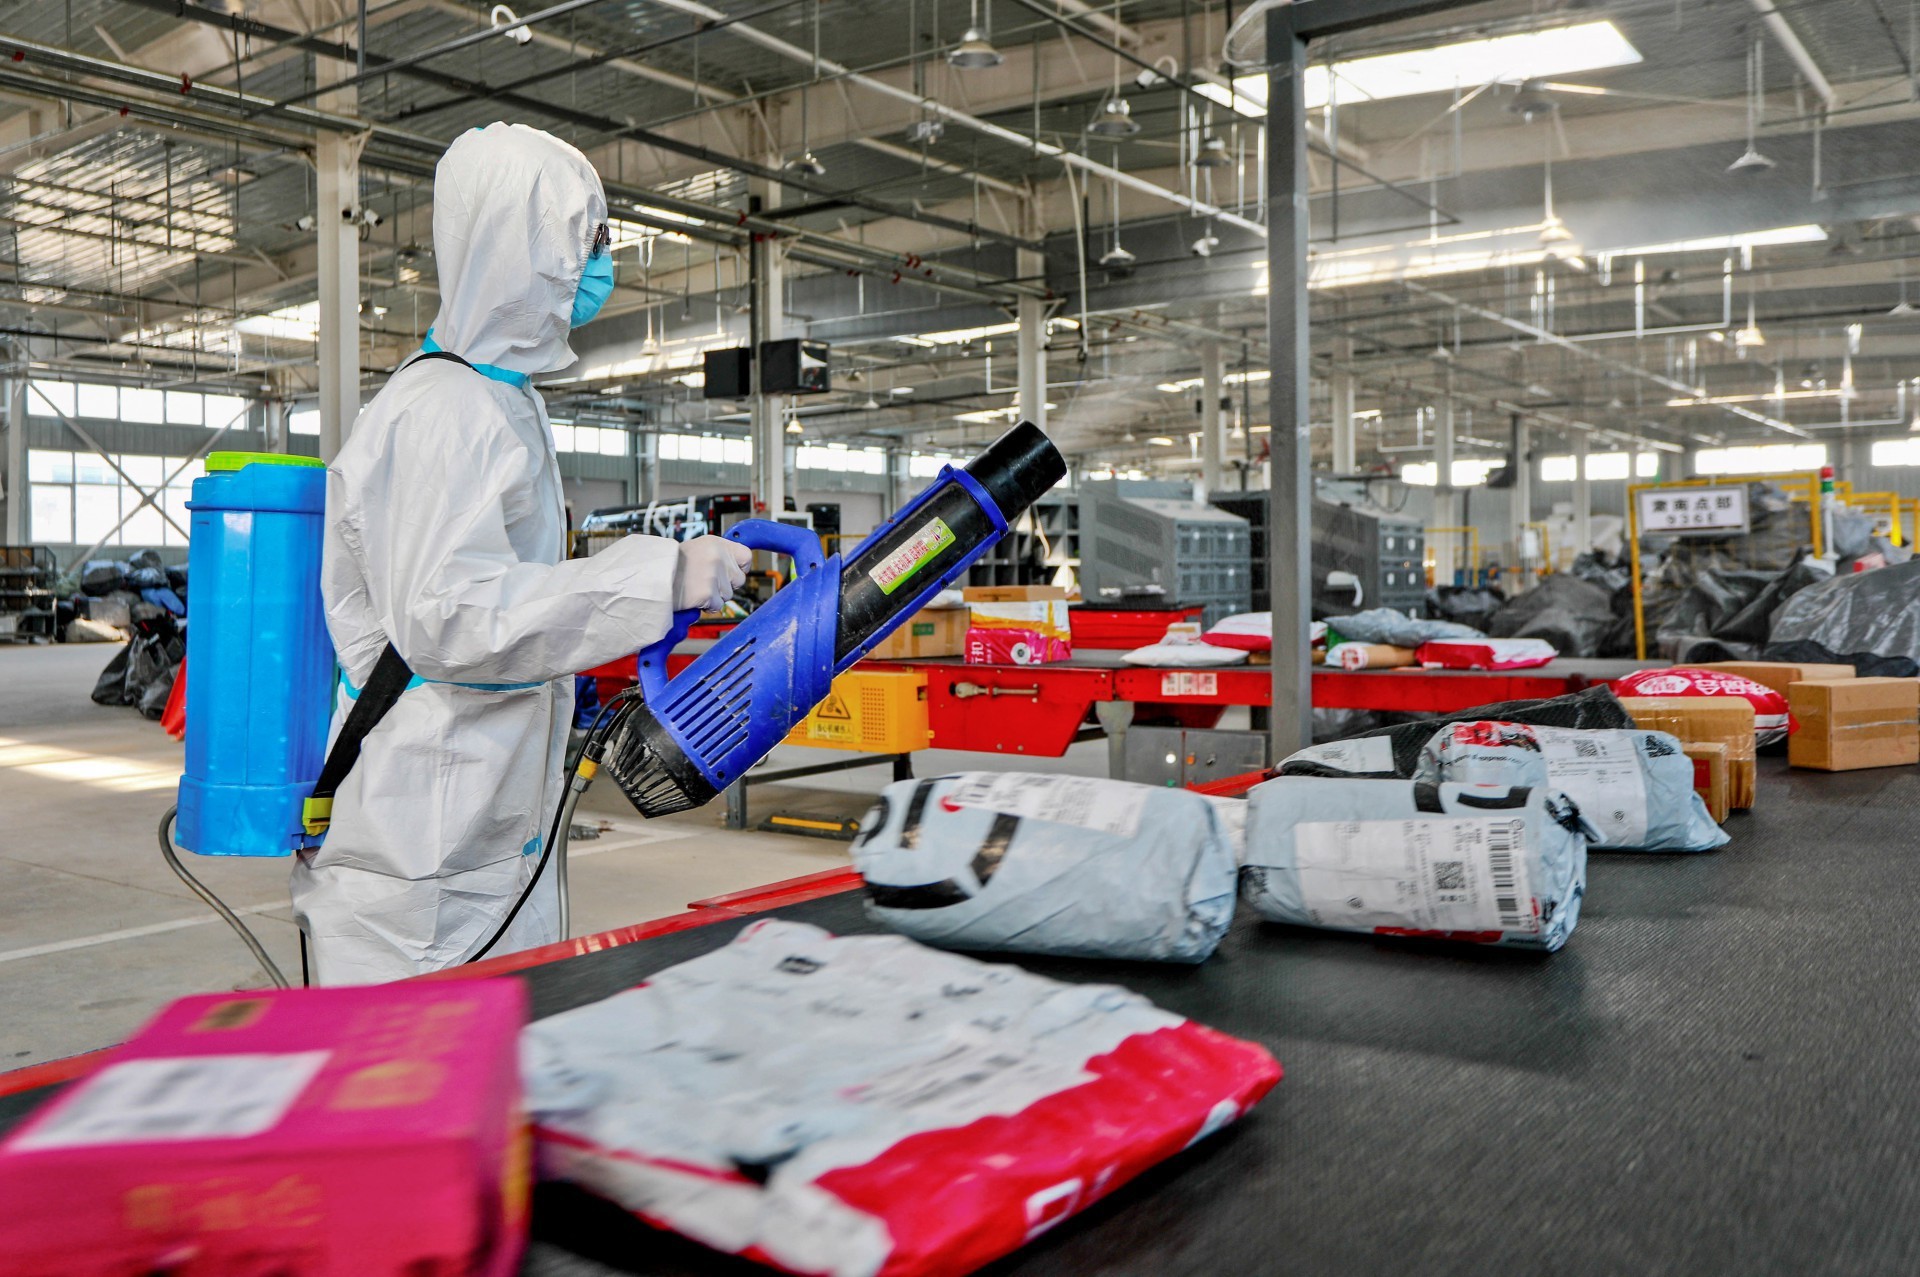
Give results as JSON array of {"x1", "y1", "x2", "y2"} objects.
[{"x1": 1196, "y1": 21, "x2": 1640, "y2": 117}]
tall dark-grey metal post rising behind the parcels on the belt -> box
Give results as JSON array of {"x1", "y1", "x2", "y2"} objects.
[{"x1": 1265, "y1": 4, "x2": 1313, "y2": 759}]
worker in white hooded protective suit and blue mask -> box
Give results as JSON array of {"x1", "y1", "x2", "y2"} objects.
[{"x1": 294, "y1": 123, "x2": 749, "y2": 985}]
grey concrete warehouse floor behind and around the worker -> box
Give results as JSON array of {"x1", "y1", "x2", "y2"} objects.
[{"x1": 0, "y1": 643, "x2": 1106, "y2": 1070}]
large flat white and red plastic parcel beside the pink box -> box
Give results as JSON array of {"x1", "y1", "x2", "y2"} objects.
[{"x1": 522, "y1": 920, "x2": 1281, "y2": 1277}]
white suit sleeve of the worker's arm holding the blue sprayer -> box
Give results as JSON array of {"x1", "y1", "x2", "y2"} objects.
[{"x1": 336, "y1": 378, "x2": 680, "y2": 684}]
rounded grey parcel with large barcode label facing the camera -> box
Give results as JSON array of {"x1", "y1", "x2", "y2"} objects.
[{"x1": 1240, "y1": 776, "x2": 1590, "y2": 952}]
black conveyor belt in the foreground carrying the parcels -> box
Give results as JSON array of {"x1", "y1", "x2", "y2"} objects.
[{"x1": 0, "y1": 759, "x2": 1920, "y2": 1277}]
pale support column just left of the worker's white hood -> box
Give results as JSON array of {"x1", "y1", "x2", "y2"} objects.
[{"x1": 313, "y1": 58, "x2": 367, "y2": 461}]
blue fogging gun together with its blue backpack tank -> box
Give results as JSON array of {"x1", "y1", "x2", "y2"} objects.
[{"x1": 175, "y1": 422, "x2": 1066, "y2": 856}]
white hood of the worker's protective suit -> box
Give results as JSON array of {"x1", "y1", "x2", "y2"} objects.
[{"x1": 434, "y1": 123, "x2": 607, "y2": 373}]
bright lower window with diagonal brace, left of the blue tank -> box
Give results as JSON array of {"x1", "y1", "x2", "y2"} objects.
[{"x1": 27, "y1": 447, "x2": 204, "y2": 545}]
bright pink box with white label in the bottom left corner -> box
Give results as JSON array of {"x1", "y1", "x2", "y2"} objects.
[{"x1": 0, "y1": 979, "x2": 532, "y2": 1277}]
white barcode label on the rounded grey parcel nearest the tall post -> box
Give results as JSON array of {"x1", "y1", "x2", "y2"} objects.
[{"x1": 1294, "y1": 816, "x2": 1540, "y2": 935}]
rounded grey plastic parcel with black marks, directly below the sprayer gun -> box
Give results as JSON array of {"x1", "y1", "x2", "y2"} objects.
[{"x1": 852, "y1": 772, "x2": 1238, "y2": 962}]
